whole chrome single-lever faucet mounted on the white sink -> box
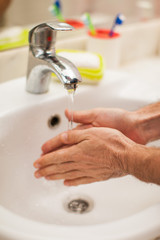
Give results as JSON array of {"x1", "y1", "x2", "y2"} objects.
[{"x1": 26, "y1": 22, "x2": 81, "y2": 94}]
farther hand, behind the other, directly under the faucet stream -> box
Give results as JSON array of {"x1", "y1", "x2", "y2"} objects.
[{"x1": 65, "y1": 108, "x2": 147, "y2": 144}]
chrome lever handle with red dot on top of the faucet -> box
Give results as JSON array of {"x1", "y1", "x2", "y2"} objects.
[{"x1": 29, "y1": 21, "x2": 74, "y2": 50}]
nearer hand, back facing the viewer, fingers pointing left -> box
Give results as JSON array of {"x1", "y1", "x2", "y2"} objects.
[{"x1": 34, "y1": 127, "x2": 136, "y2": 186}]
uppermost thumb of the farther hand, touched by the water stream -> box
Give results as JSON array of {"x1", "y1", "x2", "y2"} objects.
[{"x1": 65, "y1": 109, "x2": 96, "y2": 124}]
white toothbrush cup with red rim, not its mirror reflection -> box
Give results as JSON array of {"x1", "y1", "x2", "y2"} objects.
[{"x1": 87, "y1": 29, "x2": 121, "y2": 69}]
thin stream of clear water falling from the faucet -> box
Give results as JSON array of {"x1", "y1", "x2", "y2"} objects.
[{"x1": 68, "y1": 89, "x2": 75, "y2": 130}]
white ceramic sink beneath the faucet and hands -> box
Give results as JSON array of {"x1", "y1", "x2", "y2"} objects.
[{"x1": 0, "y1": 71, "x2": 160, "y2": 240}]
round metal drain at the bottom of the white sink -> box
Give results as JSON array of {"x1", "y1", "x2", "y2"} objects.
[{"x1": 65, "y1": 198, "x2": 93, "y2": 214}]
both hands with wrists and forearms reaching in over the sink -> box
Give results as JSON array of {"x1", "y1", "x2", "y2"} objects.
[{"x1": 34, "y1": 103, "x2": 160, "y2": 186}]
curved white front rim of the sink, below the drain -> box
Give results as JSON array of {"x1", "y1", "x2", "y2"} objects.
[{"x1": 0, "y1": 203, "x2": 160, "y2": 240}]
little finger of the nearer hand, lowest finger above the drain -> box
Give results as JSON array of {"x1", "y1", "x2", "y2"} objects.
[{"x1": 64, "y1": 177, "x2": 97, "y2": 186}]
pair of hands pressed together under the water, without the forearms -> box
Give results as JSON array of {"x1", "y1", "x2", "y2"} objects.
[{"x1": 34, "y1": 108, "x2": 146, "y2": 186}]
